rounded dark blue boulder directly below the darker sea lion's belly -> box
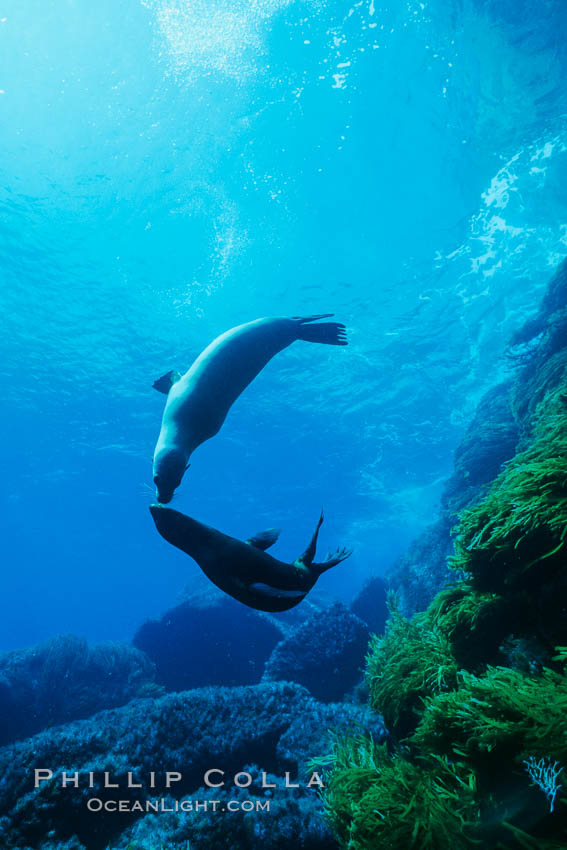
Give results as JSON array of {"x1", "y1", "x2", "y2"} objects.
[{"x1": 133, "y1": 592, "x2": 282, "y2": 691}]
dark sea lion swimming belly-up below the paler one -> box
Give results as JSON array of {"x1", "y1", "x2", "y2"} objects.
[{"x1": 150, "y1": 505, "x2": 352, "y2": 612}]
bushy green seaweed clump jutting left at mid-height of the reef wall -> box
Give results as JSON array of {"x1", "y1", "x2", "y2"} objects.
[{"x1": 366, "y1": 608, "x2": 458, "y2": 737}]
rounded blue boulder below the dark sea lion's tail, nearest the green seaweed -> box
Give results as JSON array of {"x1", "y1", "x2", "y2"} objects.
[{"x1": 264, "y1": 602, "x2": 369, "y2": 702}]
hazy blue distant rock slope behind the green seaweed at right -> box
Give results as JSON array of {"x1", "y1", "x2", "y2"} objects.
[{"x1": 386, "y1": 263, "x2": 567, "y2": 616}]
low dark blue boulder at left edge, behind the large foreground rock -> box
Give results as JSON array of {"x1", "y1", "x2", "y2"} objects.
[{"x1": 0, "y1": 635, "x2": 159, "y2": 746}]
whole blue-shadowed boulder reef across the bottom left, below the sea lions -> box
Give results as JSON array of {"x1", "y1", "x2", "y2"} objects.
[{"x1": 0, "y1": 576, "x2": 385, "y2": 850}]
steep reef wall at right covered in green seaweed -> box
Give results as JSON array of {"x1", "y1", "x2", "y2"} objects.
[{"x1": 322, "y1": 264, "x2": 567, "y2": 850}]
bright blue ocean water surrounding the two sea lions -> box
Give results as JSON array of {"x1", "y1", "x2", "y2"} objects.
[{"x1": 0, "y1": 0, "x2": 567, "y2": 649}]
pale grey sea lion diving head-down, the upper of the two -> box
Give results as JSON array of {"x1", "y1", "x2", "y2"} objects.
[{"x1": 153, "y1": 313, "x2": 347, "y2": 504}]
